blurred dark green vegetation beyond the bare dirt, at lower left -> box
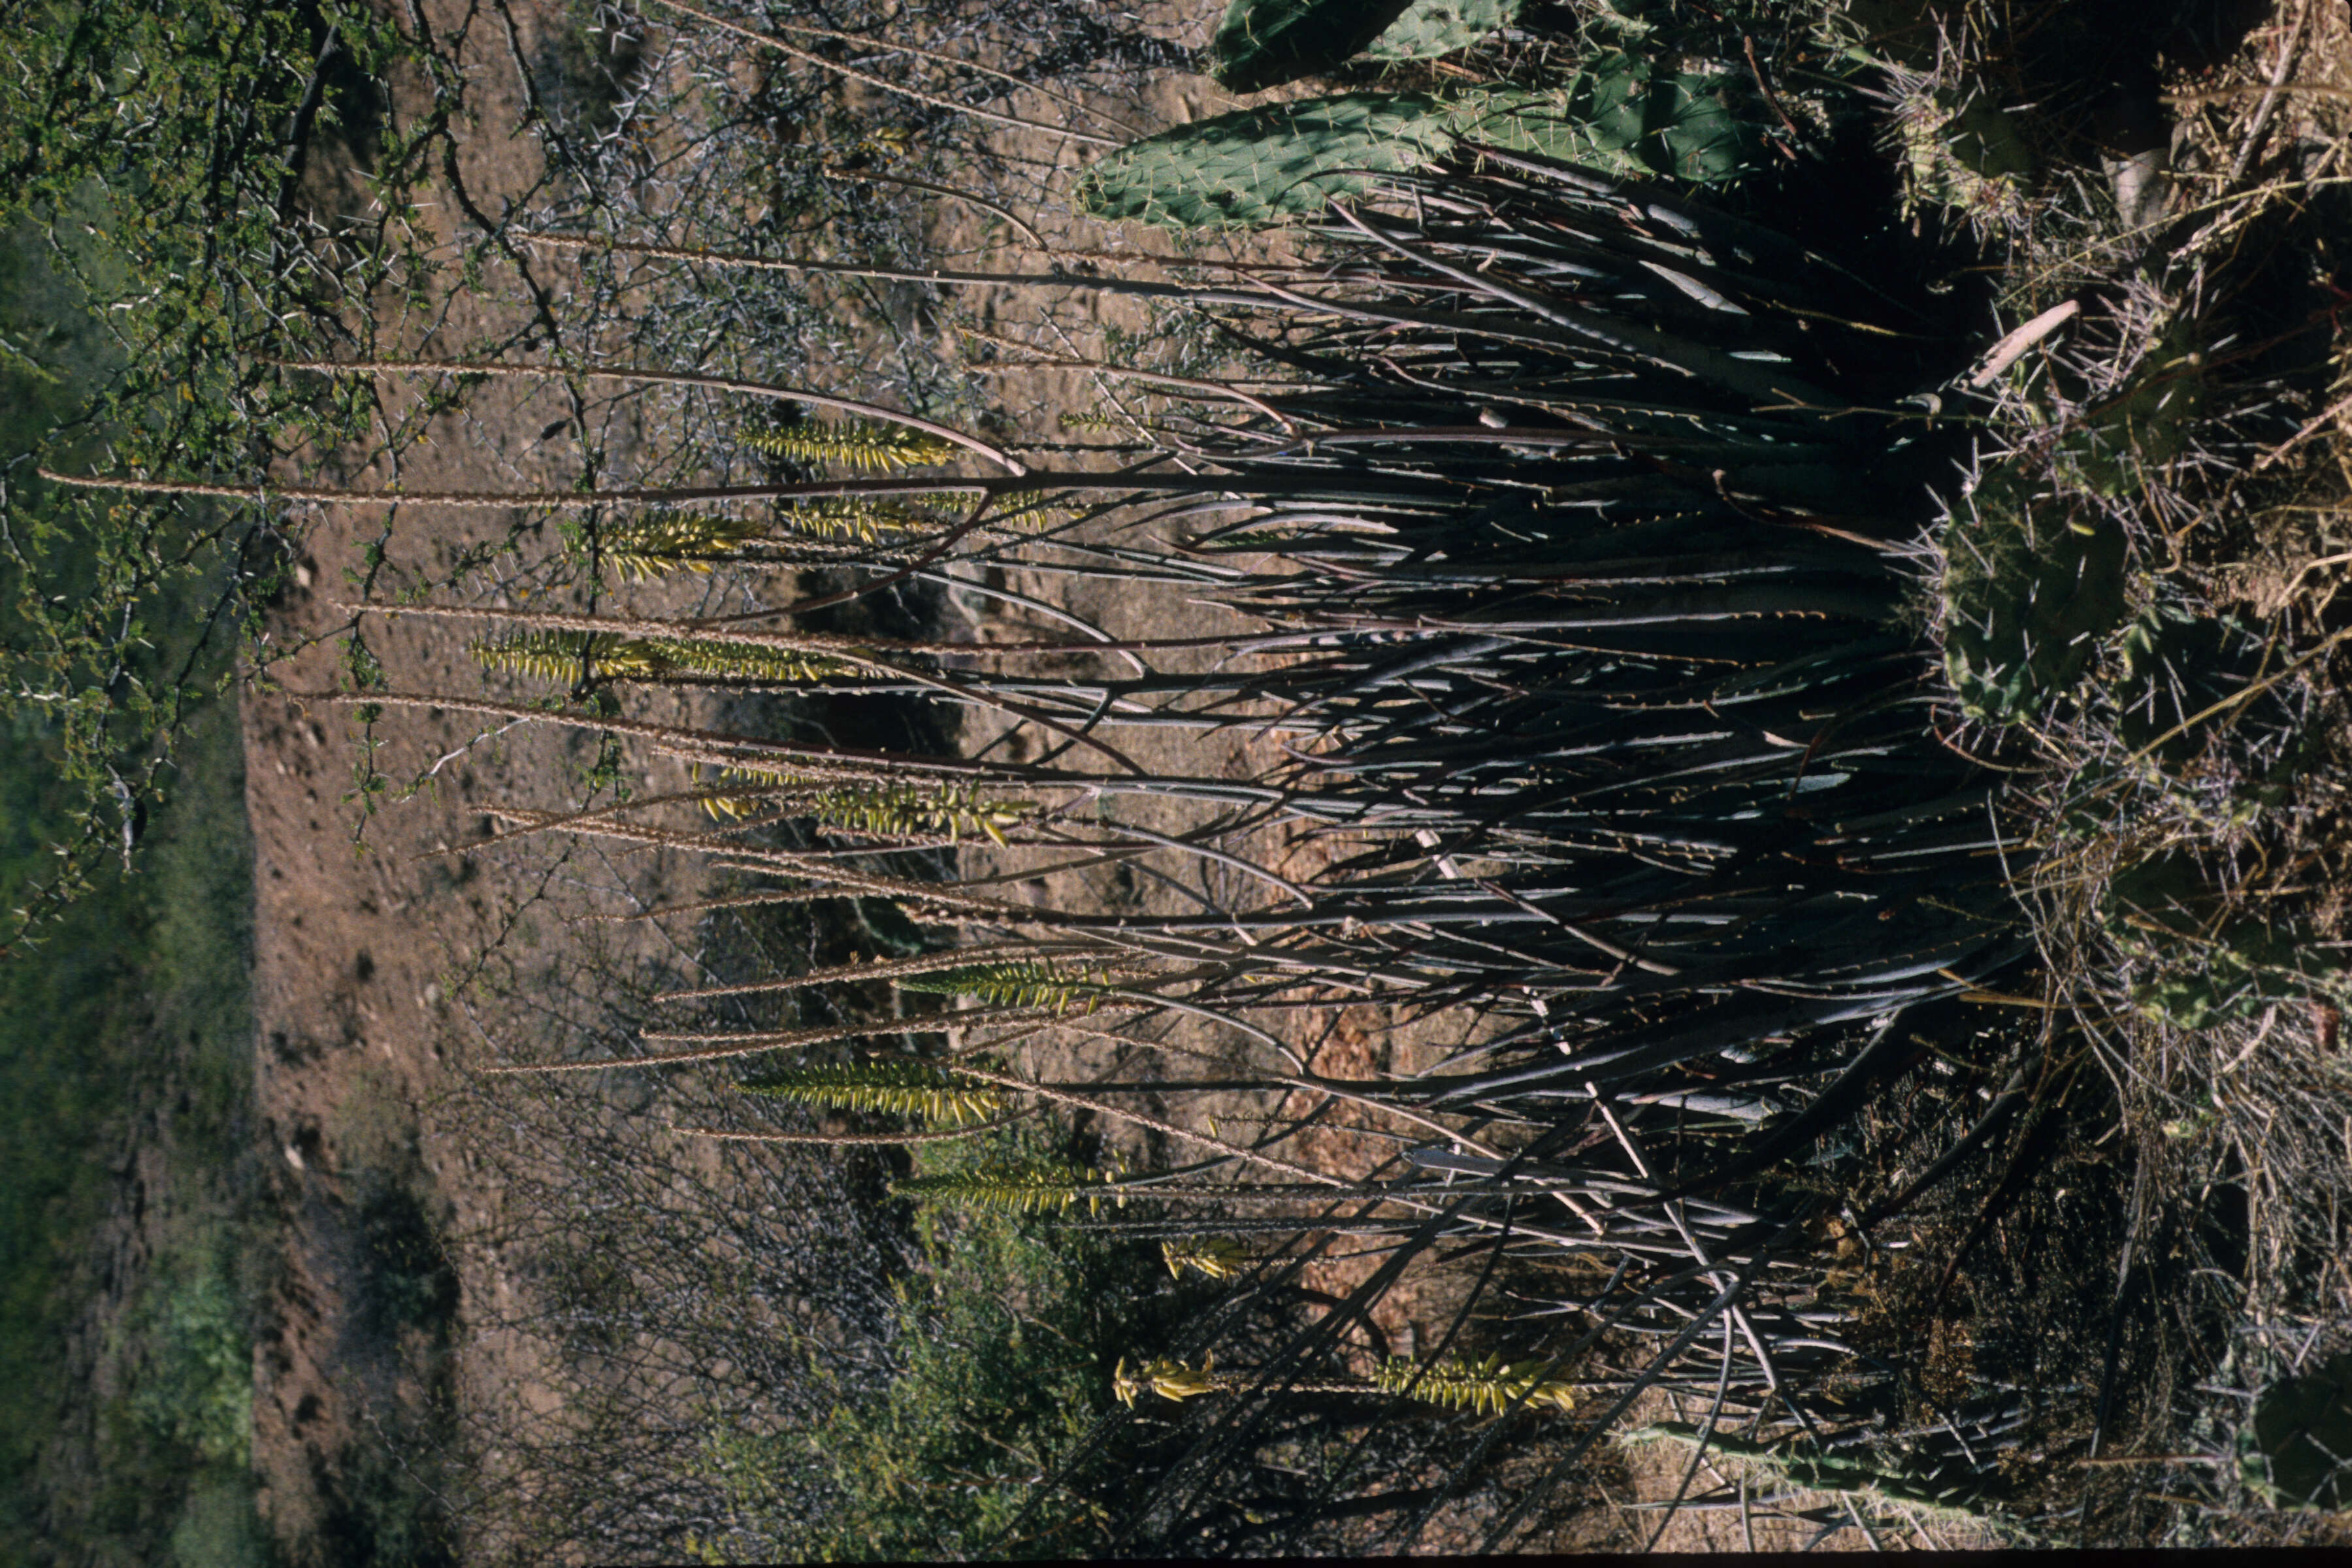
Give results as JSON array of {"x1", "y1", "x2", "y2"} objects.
[{"x1": 0, "y1": 686, "x2": 259, "y2": 1563}]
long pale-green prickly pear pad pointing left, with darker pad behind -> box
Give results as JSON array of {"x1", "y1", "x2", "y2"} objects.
[{"x1": 1077, "y1": 68, "x2": 1759, "y2": 228}]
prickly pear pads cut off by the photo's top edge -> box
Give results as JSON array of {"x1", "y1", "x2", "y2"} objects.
[{"x1": 1209, "y1": 0, "x2": 1524, "y2": 91}]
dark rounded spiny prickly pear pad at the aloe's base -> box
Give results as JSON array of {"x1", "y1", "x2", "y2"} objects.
[{"x1": 1940, "y1": 456, "x2": 2126, "y2": 724}]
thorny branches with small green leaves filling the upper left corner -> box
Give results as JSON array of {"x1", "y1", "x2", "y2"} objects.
[{"x1": 0, "y1": 0, "x2": 442, "y2": 940}]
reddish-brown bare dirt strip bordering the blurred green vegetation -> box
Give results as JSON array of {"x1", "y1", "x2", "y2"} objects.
[{"x1": 244, "y1": 7, "x2": 625, "y2": 1561}]
